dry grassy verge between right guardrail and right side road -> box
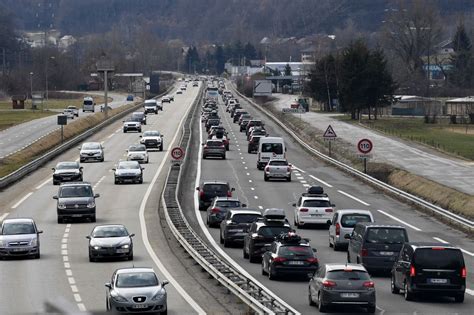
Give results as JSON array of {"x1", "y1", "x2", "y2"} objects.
[{"x1": 265, "y1": 103, "x2": 474, "y2": 219}]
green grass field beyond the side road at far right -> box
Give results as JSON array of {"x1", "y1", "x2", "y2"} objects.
[{"x1": 334, "y1": 116, "x2": 474, "y2": 161}]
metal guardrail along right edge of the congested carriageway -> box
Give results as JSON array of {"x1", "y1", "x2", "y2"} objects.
[{"x1": 232, "y1": 85, "x2": 474, "y2": 231}]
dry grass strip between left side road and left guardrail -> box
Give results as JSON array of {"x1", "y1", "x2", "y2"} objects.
[{"x1": 0, "y1": 104, "x2": 134, "y2": 177}]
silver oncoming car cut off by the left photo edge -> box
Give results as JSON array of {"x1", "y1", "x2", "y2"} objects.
[{"x1": 0, "y1": 218, "x2": 43, "y2": 259}]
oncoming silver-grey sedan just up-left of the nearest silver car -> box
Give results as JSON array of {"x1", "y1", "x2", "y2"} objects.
[{"x1": 86, "y1": 224, "x2": 135, "y2": 262}]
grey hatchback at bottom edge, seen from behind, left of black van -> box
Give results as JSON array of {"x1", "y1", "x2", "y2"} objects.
[{"x1": 308, "y1": 263, "x2": 376, "y2": 313}]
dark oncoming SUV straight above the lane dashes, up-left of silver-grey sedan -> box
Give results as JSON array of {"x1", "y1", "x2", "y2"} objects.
[{"x1": 53, "y1": 182, "x2": 100, "y2": 223}]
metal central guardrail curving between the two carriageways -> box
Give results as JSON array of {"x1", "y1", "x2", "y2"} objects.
[{"x1": 162, "y1": 87, "x2": 297, "y2": 314}]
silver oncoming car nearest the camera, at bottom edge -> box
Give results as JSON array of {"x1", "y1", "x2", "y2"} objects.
[{"x1": 105, "y1": 268, "x2": 168, "y2": 314}]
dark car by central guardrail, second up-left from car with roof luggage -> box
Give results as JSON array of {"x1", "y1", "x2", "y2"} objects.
[{"x1": 219, "y1": 209, "x2": 262, "y2": 247}]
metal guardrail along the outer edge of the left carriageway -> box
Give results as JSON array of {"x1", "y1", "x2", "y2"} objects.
[{"x1": 0, "y1": 86, "x2": 174, "y2": 189}]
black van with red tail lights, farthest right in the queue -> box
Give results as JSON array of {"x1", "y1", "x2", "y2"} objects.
[{"x1": 391, "y1": 242, "x2": 467, "y2": 303}]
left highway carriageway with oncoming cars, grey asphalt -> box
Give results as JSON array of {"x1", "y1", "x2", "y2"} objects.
[{"x1": 0, "y1": 87, "x2": 241, "y2": 314}]
